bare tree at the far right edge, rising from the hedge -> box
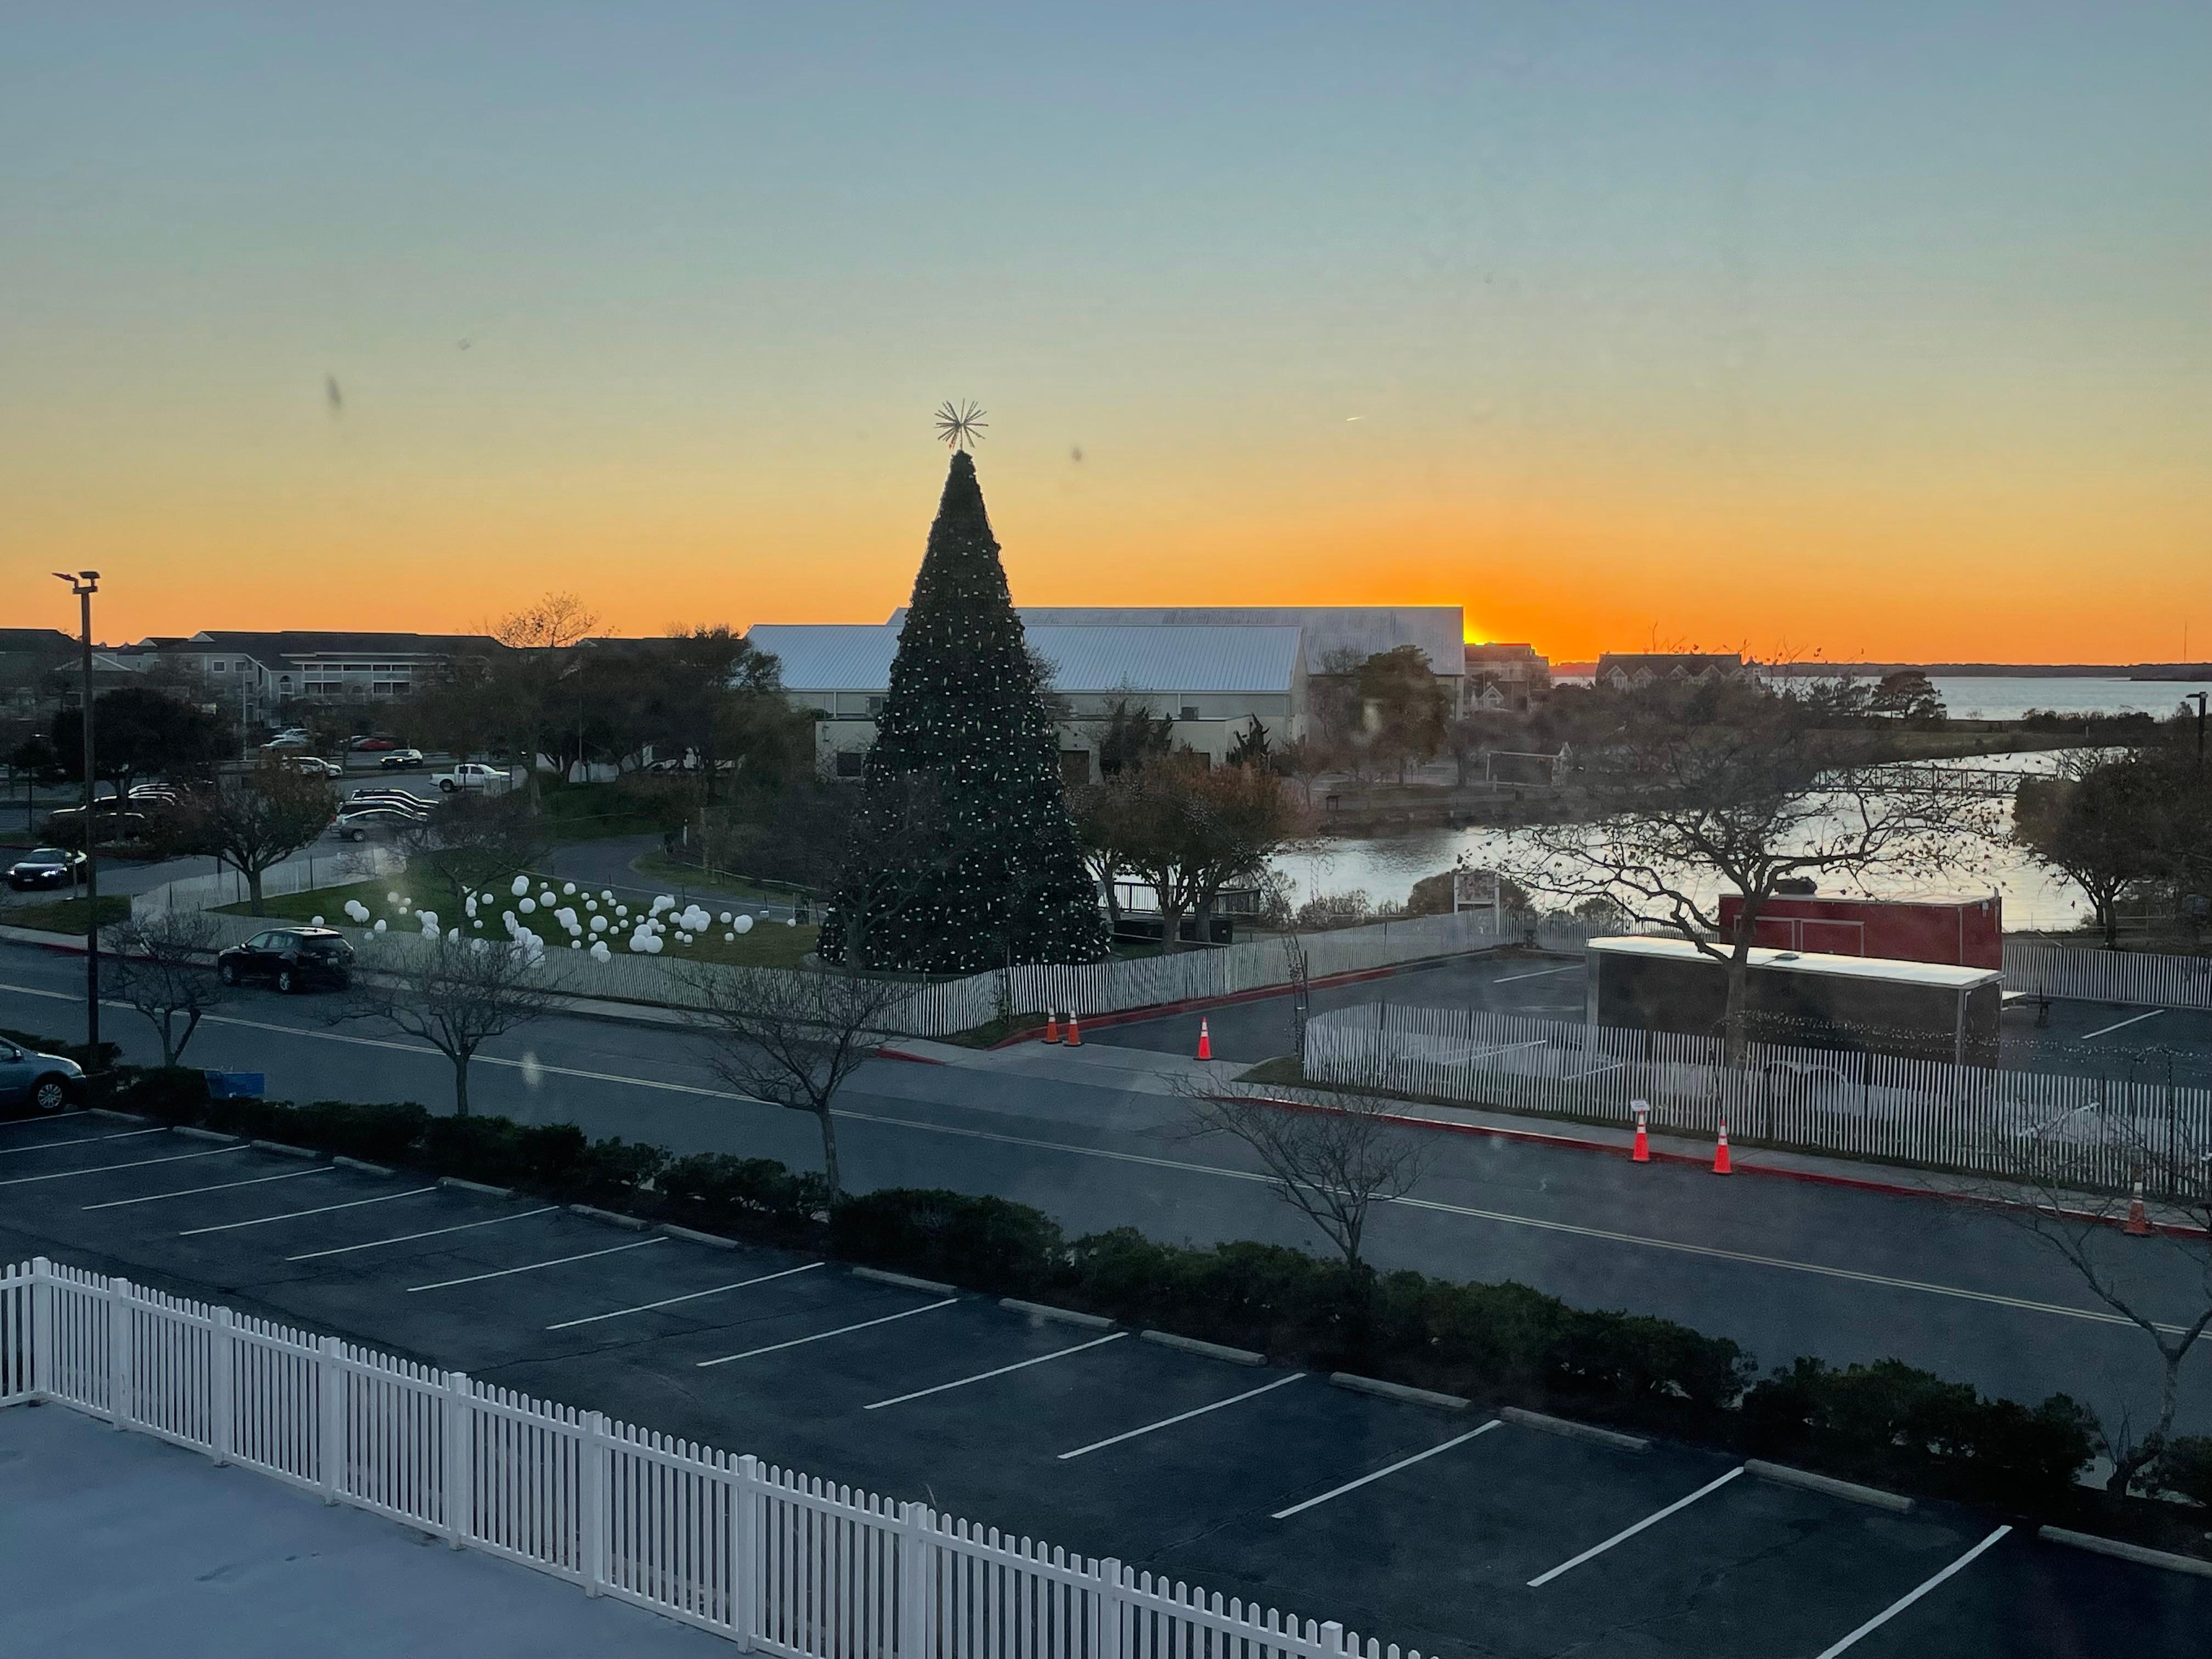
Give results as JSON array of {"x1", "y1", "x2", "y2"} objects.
[{"x1": 1982, "y1": 1110, "x2": 2212, "y2": 1493}]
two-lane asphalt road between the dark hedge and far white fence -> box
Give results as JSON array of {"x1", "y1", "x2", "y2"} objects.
[{"x1": 0, "y1": 945, "x2": 2212, "y2": 1431}]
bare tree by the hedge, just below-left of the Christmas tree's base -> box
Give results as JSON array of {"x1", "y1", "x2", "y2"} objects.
[{"x1": 670, "y1": 962, "x2": 913, "y2": 1201}]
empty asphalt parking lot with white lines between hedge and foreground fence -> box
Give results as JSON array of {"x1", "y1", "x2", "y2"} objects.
[{"x1": 0, "y1": 1113, "x2": 2212, "y2": 1655}]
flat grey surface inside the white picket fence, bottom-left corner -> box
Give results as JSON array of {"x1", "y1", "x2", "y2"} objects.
[{"x1": 0, "y1": 1404, "x2": 732, "y2": 1659}]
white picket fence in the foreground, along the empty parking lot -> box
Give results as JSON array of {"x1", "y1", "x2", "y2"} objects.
[{"x1": 0, "y1": 1256, "x2": 1420, "y2": 1659}]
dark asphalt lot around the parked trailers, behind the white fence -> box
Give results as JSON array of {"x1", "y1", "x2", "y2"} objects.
[{"x1": 1084, "y1": 956, "x2": 2212, "y2": 1088}]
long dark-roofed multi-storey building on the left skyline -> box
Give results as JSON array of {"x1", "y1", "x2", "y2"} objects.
[{"x1": 146, "y1": 628, "x2": 504, "y2": 723}]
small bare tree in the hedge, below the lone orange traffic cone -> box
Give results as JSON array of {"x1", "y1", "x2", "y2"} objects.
[{"x1": 1175, "y1": 1073, "x2": 1425, "y2": 1278}]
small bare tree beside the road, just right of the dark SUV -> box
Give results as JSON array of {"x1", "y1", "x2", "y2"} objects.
[{"x1": 338, "y1": 934, "x2": 564, "y2": 1117}]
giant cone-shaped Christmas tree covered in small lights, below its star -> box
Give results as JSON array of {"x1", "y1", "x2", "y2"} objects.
[{"x1": 821, "y1": 449, "x2": 1106, "y2": 973}]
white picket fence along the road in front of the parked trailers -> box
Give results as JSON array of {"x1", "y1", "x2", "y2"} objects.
[{"x1": 1305, "y1": 1005, "x2": 2212, "y2": 1199}]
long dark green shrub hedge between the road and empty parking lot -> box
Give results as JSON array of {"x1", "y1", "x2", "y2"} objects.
[{"x1": 56, "y1": 1057, "x2": 2159, "y2": 1511}]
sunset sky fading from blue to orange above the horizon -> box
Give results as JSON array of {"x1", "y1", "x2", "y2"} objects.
[{"x1": 0, "y1": 0, "x2": 2212, "y2": 662}]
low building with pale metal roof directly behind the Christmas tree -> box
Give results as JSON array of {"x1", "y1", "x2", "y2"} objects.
[{"x1": 746, "y1": 615, "x2": 1307, "y2": 781}]
